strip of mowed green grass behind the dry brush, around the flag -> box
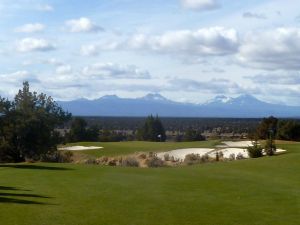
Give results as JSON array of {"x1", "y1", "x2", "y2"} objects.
[{"x1": 61, "y1": 140, "x2": 220, "y2": 157}]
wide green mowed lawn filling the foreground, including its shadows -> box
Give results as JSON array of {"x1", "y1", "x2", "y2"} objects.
[{"x1": 0, "y1": 143, "x2": 300, "y2": 225}]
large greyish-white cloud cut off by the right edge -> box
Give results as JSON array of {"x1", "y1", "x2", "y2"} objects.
[{"x1": 238, "y1": 28, "x2": 300, "y2": 70}]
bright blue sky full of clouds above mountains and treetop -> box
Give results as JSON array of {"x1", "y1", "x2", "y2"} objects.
[{"x1": 0, "y1": 0, "x2": 300, "y2": 106}]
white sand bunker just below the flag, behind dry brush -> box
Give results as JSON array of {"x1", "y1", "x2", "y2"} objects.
[{"x1": 157, "y1": 148, "x2": 214, "y2": 160}]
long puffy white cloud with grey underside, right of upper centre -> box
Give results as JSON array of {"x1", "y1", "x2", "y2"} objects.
[{"x1": 127, "y1": 27, "x2": 239, "y2": 56}]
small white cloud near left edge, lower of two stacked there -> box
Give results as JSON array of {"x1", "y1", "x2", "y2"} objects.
[{"x1": 16, "y1": 38, "x2": 55, "y2": 52}]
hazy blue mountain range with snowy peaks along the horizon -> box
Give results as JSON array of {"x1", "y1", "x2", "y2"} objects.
[{"x1": 58, "y1": 94, "x2": 300, "y2": 118}]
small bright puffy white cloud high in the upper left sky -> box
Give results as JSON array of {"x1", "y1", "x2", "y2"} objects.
[{"x1": 65, "y1": 17, "x2": 103, "y2": 33}]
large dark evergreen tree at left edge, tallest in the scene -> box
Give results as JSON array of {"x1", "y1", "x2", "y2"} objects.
[{"x1": 0, "y1": 82, "x2": 71, "y2": 162}]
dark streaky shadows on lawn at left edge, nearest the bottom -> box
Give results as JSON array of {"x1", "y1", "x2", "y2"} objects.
[{"x1": 0, "y1": 186, "x2": 52, "y2": 205}]
